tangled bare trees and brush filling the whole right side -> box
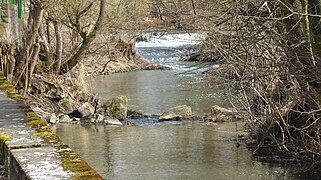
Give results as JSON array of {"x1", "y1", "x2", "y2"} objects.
[{"x1": 189, "y1": 0, "x2": 321, "y2": 165}]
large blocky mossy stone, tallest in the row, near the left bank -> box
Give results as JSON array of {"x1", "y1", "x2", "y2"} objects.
[{"x1": 99, "y1": 96, "x2": 128, "y2": 120}]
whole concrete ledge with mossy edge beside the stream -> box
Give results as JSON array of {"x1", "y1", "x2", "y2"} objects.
[{"x1": 0, "y1": 79, "x2": 103, "y2": 180}]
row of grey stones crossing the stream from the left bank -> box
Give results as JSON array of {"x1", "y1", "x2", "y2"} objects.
[{"x1": 33, "y1": 87, "x2": 241, "y2": 126}]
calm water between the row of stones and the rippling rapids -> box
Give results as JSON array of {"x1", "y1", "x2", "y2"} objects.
[{"x1": 88, "y1": 71, "x2": 228, "y2": 115}]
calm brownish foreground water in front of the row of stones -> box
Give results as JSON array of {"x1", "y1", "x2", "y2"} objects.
[{"x1": 56, "y1": 123, "x2": 300, "y2": 179}]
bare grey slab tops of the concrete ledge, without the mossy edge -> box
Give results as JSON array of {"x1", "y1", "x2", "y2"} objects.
[{"x1": 0, "y1": 90, "x2": 101, "y2": 180}]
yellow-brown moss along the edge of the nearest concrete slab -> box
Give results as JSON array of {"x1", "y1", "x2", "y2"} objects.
[{"x1": 58, "y1": 145, "x2": 103, "y2": 180}]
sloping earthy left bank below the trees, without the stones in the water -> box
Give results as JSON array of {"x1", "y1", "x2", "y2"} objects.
[{"x1": 26, "y1": 37, "x2": 169, "y2": 123}]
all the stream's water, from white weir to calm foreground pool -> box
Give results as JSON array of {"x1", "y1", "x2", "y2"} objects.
[{"x1": 55, "y1": 35, "x2": 306, "y2": 179}]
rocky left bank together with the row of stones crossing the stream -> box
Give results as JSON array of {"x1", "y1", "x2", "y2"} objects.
[{"x1": 27, "y1": 33, "x2": 240, "y2": 125}]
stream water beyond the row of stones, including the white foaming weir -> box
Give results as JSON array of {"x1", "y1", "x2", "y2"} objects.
[{"x1": 88, "y1": 34, "x2": 229, "y2": 115}]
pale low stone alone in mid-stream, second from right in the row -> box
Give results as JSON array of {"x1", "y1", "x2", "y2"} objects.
[{"x1": 159, "y1": 105, "x2": 193, "y2": 121}]
